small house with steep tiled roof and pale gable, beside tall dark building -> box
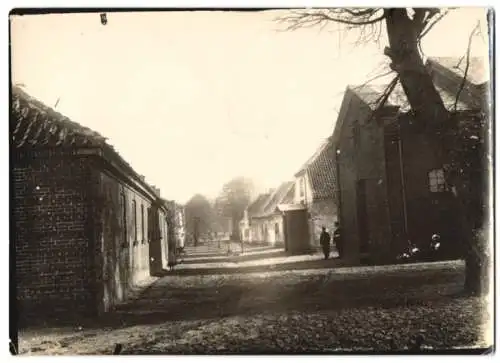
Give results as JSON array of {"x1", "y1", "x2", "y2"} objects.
[{"x1": 293, "y1": 138, "x2": 338, "y2": 247}]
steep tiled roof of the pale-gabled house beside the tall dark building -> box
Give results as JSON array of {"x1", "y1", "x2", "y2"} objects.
[{"x1": 307, "y1": 138, "x2": 337, "y2": 199}]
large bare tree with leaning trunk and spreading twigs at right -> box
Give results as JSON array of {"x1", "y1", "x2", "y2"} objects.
[{"x1": 277, "y1": 8, "x2": 489, "y2": 293}]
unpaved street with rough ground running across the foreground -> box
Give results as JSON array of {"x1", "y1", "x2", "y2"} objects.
[{"x1": 20, "y1": 246, "x2": 490, "y2": 354}]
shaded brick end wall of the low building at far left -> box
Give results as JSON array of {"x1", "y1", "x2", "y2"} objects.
[{"x1": 12, "y1": 151, "x2": 92, "y2": 317}]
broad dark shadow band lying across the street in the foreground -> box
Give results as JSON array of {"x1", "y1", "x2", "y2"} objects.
[{"x1": 107, "y1": 271, "x2": 463, "y2": 326}]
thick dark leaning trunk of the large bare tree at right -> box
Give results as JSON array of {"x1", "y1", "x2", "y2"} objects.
[{"x1": 385, "y1": 8, "x2": 488, "y2": 294}]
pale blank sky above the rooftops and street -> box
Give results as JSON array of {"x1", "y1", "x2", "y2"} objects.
[{"x1": 11, "y1": 8, "x2": 487, "y2": 202}]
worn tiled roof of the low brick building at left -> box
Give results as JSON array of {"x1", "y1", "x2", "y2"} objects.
[{"x1": 9, "y1": 86, "x2": 161, "y2": 200}]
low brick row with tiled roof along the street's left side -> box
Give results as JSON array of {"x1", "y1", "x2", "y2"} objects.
[{"x1": 10, "y1": 87, "x2": 188, "y2": 317}]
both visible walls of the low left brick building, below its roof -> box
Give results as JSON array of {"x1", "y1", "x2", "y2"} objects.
[{"x1": 12, "y1": 151, "x2": 168, "y2": 318}]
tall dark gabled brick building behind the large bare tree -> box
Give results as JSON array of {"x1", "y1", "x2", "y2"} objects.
[{"x1": 333, "y1": 58, "x2": 485, "y2": 263}]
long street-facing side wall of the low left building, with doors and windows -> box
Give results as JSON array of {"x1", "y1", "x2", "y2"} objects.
[{"x1": 92, "y1": 160, "x2": 168, "y2": 311}]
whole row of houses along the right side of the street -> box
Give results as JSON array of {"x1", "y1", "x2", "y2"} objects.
[{"x1": 240, "y1": 57, "x2": 491, "y2": 264}]
